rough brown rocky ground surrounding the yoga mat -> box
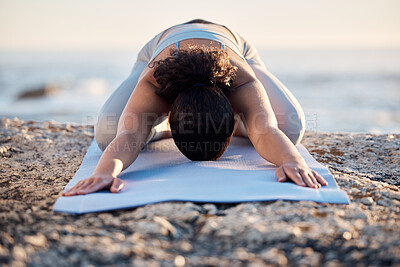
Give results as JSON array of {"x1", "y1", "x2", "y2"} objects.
[{"x1": 0, "y1": 118, "x2": 400, "y2": 266}]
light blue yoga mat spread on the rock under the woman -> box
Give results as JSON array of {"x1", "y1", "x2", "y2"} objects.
[{"x1": 53, "y1": 137, "x2": 350, "y2": 214}]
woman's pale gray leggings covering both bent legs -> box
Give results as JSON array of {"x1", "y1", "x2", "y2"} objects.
[{"x1": 94, "y1": 23, "x2": 305, "y2": 150}]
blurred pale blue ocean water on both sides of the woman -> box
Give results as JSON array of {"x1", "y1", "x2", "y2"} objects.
[{"x1": 0, "y1": 50, "x2": 400, "y2": 133}]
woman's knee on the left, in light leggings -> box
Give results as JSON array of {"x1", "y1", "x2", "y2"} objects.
[{"x1": 94, "y1": 114, "x2": 119, "y2": 151}]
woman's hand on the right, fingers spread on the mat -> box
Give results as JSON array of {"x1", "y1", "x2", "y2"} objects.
[{"x1": 275, "y1": 162, "x2": 328, "y2": 189}]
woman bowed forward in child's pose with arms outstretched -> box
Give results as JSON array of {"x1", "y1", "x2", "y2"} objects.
[{"x1": 63, "y1": 19, "x2": 327, "y2": 196}]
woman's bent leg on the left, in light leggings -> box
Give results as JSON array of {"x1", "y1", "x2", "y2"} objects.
[{"x1": 94, "y1": 30, "x2": 165, "y2": 150}]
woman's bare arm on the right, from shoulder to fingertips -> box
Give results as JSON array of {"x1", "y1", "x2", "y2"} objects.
[{"x1": 229, "y1": 77, "x2": 327, "y2": 188}]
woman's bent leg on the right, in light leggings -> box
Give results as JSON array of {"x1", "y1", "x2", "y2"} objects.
[{"x1": 236, "y1": 33, "x2": 305, "y2": 145}]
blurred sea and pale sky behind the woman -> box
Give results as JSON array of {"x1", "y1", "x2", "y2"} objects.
[{"x1": 0, "y1": 0, "x2": 400, "y2": 133}]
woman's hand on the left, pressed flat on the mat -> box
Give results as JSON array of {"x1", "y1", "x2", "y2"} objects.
[{"x1": 62, "y1": 175, "x2": 124, "y2": 197}]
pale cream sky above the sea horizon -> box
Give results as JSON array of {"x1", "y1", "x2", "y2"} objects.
[{"x1": 0, "y1": 0, "x2": 400, "y2": 51}]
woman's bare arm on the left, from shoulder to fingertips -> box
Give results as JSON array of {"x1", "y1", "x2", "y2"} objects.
[{"x1": 62, "y1": 75, "x2": 169, "y2": 196}]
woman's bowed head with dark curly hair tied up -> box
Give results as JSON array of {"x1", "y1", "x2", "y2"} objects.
[{"x1": 150, "y1": 46, "x2": 236, "y2": 160}]
